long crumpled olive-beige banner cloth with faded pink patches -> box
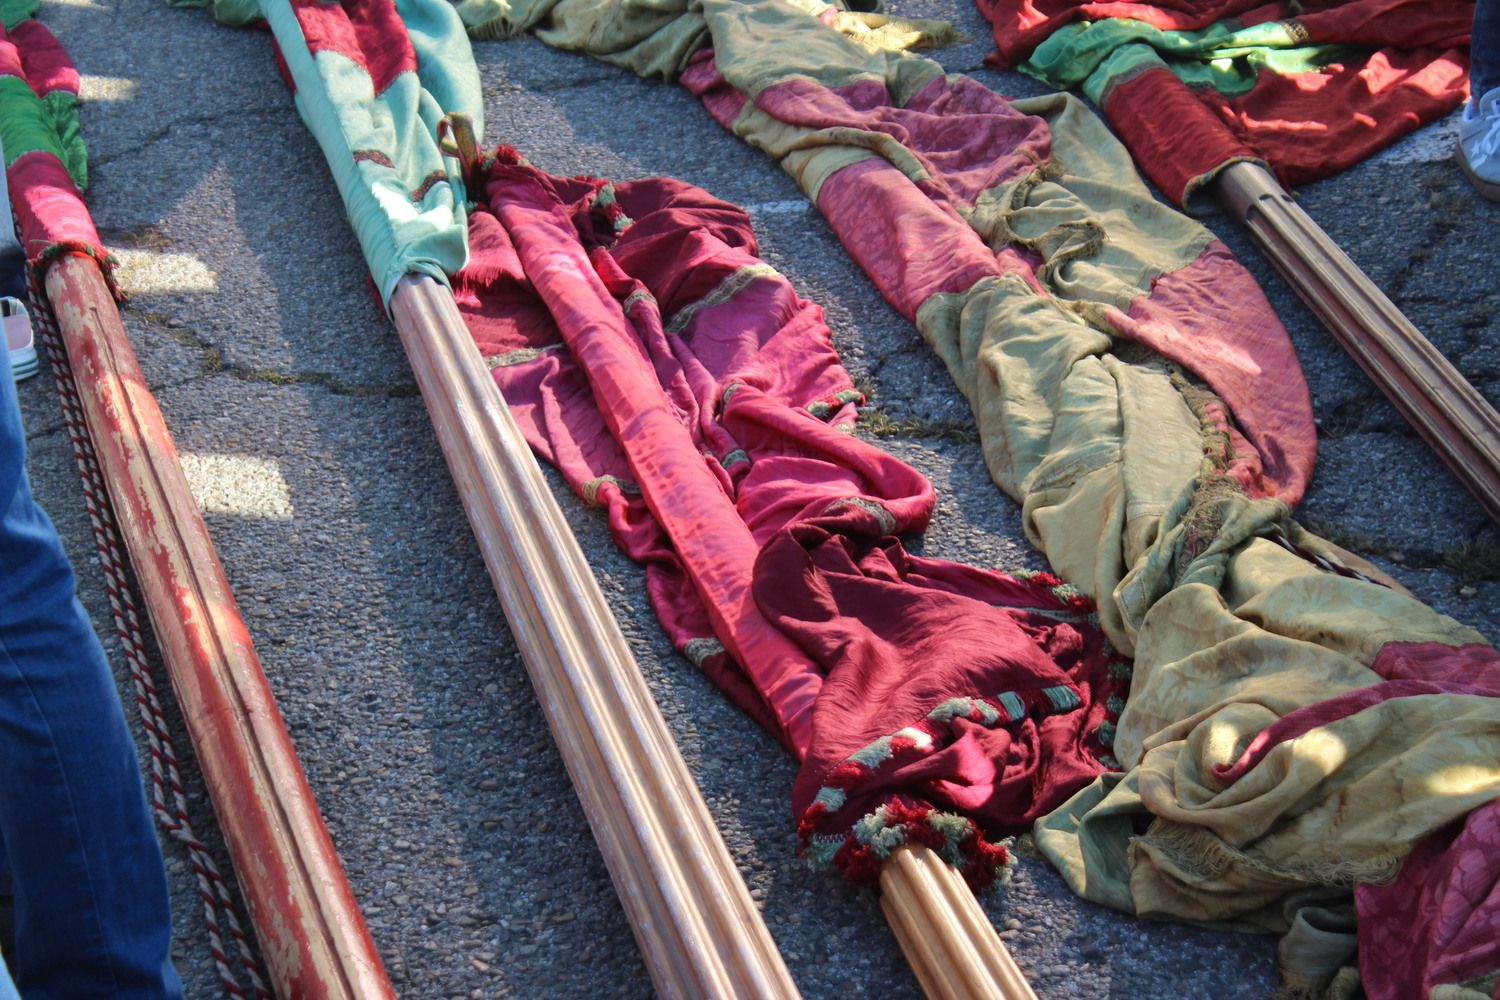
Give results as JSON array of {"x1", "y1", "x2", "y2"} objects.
[{"x1": 444, "y1": 0, "x2": 1500, "y2": 991}]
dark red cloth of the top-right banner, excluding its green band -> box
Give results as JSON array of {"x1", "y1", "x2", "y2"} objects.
[{"x1": 977, "y1": 0, "x2": 1473, "y2": 204}]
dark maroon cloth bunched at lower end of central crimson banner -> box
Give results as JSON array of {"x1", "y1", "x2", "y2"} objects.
[{"x1": 756, "y1": 508, "x2": 1124, "y2": 834}]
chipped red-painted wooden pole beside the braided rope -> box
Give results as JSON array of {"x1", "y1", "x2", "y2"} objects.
[{"x1": 47, "y1": 253, "x2": 396, "y2": 1000}]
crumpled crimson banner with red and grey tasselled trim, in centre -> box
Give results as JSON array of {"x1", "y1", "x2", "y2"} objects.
[{"x1": 455, "y1": 150, "x2": 1125, "y2": 882}]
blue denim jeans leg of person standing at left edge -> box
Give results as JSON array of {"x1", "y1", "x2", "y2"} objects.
[{"x1": 0, "y1": 355, "x2": 182, "y2": 1000}]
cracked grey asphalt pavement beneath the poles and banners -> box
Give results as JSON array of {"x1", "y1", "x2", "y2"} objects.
[{"x1": 21, "y1": 0, "x2": 1500, "y2": 997}]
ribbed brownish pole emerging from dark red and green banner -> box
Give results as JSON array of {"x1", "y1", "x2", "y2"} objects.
[{"x1": 1215, "y1": 163, "x2": 1500, "y2": 522}]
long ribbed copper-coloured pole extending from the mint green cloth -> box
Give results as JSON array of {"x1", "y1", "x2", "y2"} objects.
[{"x1": 392, "y1": 274, "x2": 798, "y2": 1000}]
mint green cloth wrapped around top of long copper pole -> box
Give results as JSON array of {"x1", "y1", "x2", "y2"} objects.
[{"x1": 263, "y1": 0, "x2": 483, "y2": 301}]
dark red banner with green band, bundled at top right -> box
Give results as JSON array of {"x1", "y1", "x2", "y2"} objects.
[{"x1": 978, "y1": 0, "x2": 1475, "y2": 204}]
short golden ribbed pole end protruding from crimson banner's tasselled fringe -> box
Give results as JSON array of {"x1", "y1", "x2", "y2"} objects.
[{"x1": 881, "y1": 846, "x2": 1037, "y2": 1000}]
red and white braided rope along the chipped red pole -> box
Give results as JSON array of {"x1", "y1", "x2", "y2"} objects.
[{"x1": 29, "y1": 271, "x2": 272, "y2": 1000}]
